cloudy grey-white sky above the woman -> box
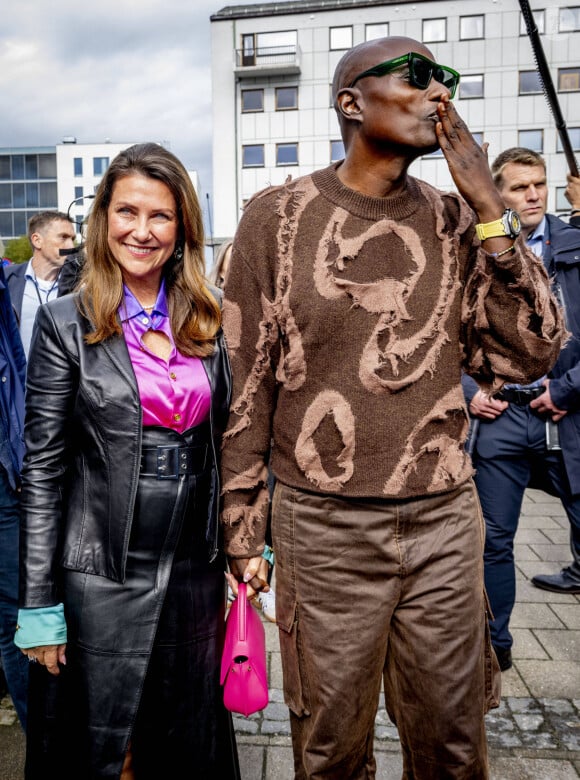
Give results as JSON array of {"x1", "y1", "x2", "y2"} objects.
[{"x1": 0, "y1": 0, "x2": 256, "y2": 206}]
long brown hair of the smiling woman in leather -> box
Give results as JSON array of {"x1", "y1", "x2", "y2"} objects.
[{"x1": 79, "y1": 143, "x2": 221, "y2": 357}]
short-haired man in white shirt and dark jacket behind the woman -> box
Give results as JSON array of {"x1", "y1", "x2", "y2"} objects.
[{"x1": 6, "y1": 211, "x2": 75, "y2": 355}]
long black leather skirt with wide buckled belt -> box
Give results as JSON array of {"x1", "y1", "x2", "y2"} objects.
[{"x1": 26, "y1": 425, "x2": 239, "y2": 780}]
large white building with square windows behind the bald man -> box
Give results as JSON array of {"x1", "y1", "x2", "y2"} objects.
[{"x1": 211, "y1": 0, "x2": 580, "y2": 245}]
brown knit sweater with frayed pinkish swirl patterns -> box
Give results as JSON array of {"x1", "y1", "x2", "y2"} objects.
[{"x1": 222, "y1": 166, "x2": 563, "y2": 557}]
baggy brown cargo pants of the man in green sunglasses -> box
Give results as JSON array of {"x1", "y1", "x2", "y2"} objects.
[{"x1": 272, "y1": 481, "x2": 500, "y2": 780}]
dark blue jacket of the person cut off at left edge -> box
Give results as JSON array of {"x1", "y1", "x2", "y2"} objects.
[{"x1": 0, "y1": 266, "x2": 26, "y2": 489}]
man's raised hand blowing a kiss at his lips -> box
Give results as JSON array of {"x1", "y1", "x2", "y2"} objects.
[{"x1": 435, "y1": 95, "x2": 504, "y2": 222}]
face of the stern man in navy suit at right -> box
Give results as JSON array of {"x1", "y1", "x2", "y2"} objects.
[{"x1": 498, "y1": 162, "x2": 548, "y2": 233}]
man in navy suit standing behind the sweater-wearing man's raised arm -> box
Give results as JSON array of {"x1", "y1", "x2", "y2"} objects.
[{"x1": 463, "y1": 147, "x2": 580, "y2": 670}]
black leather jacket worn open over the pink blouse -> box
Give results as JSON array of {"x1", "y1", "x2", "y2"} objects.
[{"x1": 21, "y1": 290, "x2": 231, "y2": 607}]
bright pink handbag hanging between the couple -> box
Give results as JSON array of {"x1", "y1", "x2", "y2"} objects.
[{"x1": 220, "y1": 582, "x2": 268, "y2": 718}]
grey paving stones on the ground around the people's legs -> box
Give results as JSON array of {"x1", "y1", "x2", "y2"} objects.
[{"x1": 0, "y1": 490, "x2": 580, "y2": 780}]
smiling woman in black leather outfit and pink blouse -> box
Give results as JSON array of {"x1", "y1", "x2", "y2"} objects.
[{"x1": 16, "y1": 143, "x2": 239, "y2": 780}]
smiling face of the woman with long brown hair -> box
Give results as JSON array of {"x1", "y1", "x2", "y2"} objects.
[{"x1": 107, "y1": 174, "x2": 179, "y2": 289}]
